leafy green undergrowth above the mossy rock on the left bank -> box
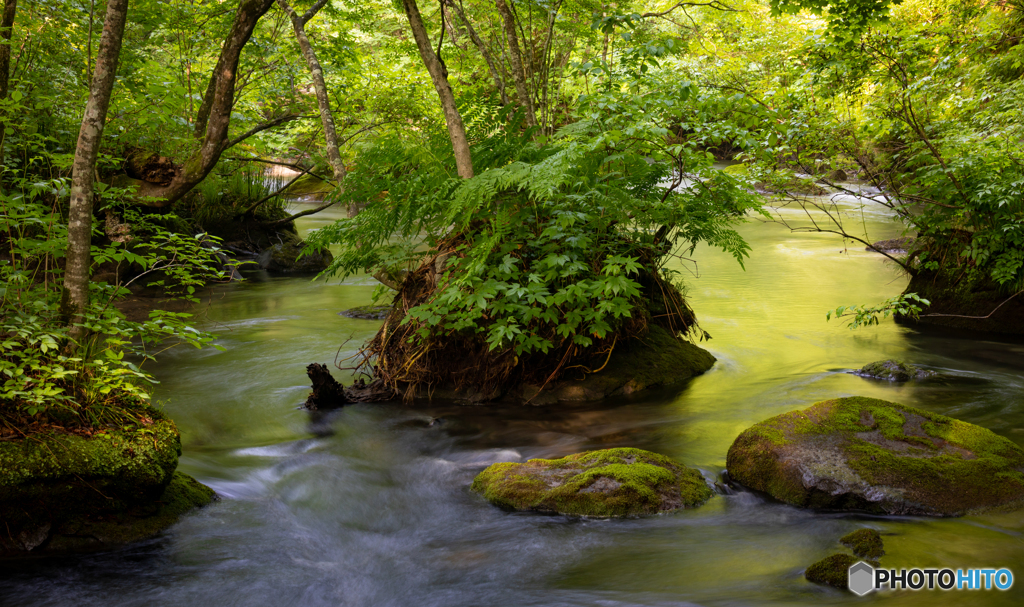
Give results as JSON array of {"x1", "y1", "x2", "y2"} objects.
[{"x1": 0, "y1": 180, "x2": 220, "y2": 426}]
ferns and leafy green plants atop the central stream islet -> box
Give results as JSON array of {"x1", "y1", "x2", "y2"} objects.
[{"x1": 308, "y1": 66, "x2": 760, "y2": 356}]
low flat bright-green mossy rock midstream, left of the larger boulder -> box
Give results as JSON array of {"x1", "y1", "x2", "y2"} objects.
[{"x1": 472, "y1": 448, "x2": 712, "y2": 517}]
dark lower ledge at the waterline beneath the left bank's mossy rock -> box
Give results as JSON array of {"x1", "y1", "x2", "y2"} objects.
[{"x1": 0, "y1": 472, "x2": 216, "y2": 558}]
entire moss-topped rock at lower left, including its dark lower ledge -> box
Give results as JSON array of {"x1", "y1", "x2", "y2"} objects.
[{"x1": 0, "y1": 409, "x2": 214, "y2": 558}]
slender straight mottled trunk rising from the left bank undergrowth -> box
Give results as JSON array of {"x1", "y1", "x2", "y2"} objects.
[{"x1": 61, "y1": 0, "x2": 128, "y2": 339}]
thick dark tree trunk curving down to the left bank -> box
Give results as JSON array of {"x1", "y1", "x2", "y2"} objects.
[{"x1": 135, "y1": 0, "x2": 280, "y2": 207}]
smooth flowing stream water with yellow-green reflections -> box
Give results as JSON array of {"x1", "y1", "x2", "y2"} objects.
[{"x1": 0, "y1": 191, "x2": 1024, "y2": 607}]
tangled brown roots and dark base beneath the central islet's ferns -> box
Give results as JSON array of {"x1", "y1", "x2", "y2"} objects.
[{"x1": 346, "y1": 239, "x2": 710, "y2": 401}]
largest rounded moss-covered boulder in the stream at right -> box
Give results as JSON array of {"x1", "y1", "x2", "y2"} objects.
[{"x1": 726, "y1": 397, "x2": 1024, "y2": 516}]
